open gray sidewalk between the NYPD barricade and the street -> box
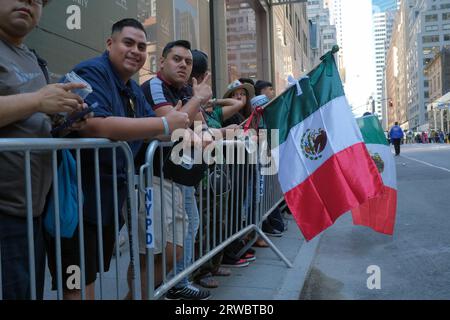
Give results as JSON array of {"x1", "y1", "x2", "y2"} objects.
[{"x1": 207, "y1": 215, "x2": 320, "y2": 300}]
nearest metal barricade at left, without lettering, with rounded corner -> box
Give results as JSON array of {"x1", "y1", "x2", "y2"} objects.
[{"x1": 0, "y1": 139, "x2": 141, "y2": 300}]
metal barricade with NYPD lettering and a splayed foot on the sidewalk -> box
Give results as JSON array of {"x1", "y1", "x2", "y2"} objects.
[{"x1": 139, "y1": 141, "x2": 292, "y2": 299}]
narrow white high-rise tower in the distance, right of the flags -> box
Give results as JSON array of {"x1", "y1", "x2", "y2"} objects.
[{"x1": 373, "y1": 11, "x2": 396, "y2": 120}]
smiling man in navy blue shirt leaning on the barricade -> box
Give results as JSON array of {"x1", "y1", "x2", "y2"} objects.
[{"x1": 47, "y1": 19, "x2": 189, "y2": 299}]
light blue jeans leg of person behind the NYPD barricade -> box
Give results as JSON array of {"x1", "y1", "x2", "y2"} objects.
[{"x1": 176, "y1": 185, "x2": 200, "y2": 288}]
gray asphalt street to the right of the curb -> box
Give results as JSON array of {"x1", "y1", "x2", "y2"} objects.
[{"x1": 301, "y1": 144, "x2": 450, "y2": 300}]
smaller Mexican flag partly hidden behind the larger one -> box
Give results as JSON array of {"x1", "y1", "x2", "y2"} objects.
[{"x1": 352, "y1": 116, "x2": 397, "y2": 235}]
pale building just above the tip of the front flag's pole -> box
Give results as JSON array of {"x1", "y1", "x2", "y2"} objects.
[{"x1": 307, "y1": 0, "x2": 337, "y2": 65}]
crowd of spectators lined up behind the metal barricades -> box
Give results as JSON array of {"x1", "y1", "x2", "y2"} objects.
[{"x1": 0, "y1": 0, "x2": 284, "y2": 300}]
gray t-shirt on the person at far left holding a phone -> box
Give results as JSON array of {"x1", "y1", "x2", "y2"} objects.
[{"x1": 0, "y1": 39, "x2": 52, "y2": 217}]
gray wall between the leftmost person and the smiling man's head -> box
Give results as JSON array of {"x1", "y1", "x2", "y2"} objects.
[{"x1": 26, "y1": 0, "x2": 138, "y2": 82}]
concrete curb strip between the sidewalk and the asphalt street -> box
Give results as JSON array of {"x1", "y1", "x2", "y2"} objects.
[{"x1": 273, "y1": 235, "x2": 322, "y2": 300}]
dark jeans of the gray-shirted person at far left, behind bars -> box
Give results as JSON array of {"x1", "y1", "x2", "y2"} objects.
[{"x1": 0, "y1": 213, "x2": 45, "y2": 300}]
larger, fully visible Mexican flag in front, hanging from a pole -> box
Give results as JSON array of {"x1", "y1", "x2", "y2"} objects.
[{"x1": 264, "y1": 52, "x2": 383, "y2": 241}]
